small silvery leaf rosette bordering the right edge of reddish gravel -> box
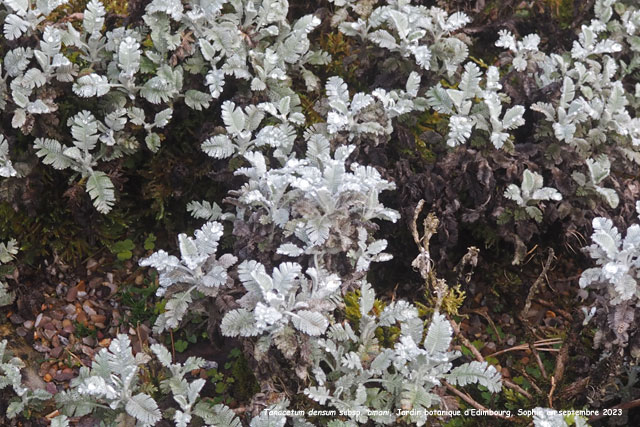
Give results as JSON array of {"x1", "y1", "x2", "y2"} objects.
[{"x1": 140, "y1": 221, "x2": 237, "y2": 332}]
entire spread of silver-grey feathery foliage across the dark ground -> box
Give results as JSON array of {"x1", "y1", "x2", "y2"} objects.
[{"x1": 0, "y1": 0, "x2": 640, "y2": 427}]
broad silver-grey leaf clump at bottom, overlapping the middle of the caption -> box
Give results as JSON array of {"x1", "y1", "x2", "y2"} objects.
[{"x1": 304, "y1": 290, "x2": 501, "y2": 426}]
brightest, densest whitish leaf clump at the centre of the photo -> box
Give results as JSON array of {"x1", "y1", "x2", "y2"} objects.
[{"x1": 234, "y1": 140, "x2": 399, "y2": 254}]
